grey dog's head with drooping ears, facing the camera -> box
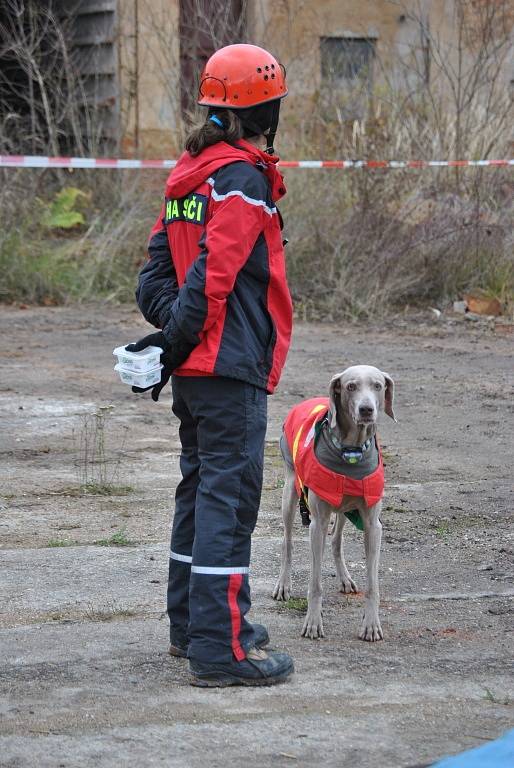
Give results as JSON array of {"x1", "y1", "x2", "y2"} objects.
[{"x1": 329, "y1": 365, "x2": 396, "y2": 428}]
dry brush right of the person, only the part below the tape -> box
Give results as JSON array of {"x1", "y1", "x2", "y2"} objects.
[{"x1": 283, "y1": 160, "x2": 514, "y2": 320}]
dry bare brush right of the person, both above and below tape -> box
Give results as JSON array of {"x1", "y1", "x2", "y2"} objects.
[{"x1": 279, "y1": 0, "x2": 514, "y2": 319}]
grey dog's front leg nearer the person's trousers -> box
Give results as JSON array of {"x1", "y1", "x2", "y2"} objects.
[{"x1": 302, "y1": 491, "x2": 331, "y2": 639}]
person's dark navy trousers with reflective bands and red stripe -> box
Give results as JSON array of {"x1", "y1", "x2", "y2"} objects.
[{"x1": 168, "y1": 376, "x2": 267, "y2": 662}]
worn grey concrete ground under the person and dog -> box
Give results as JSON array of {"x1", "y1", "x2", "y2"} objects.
[{"x1": 0, "y1": 306, "x2": 514, "y2": 768}]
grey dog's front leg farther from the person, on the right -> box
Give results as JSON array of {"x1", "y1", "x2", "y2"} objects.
[{"x1": 359, "y1": 502, "x2": 384, "y2": 642}]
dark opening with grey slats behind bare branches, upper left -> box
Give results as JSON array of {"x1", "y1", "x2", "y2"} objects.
[{"x1": 0, "y1": 0, "x2": 118, "y2": 155}]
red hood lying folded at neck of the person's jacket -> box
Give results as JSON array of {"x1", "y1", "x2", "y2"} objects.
[{"x1": 166, "y1": 139, "x2": 286, "y2": 202}]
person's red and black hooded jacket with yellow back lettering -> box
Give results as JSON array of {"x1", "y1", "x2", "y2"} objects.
[{"x1": 136, "y1": 140, "x2": 292, "y2": 393}]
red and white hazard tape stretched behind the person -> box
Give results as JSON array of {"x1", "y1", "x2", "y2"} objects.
[{"x1": 0, "y1": 155, "x2": 514, "y2": 169}]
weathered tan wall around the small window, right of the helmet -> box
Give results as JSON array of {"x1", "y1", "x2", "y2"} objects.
[{"x1": 249, "y1": 0, "x2": 508, "y2": 96}]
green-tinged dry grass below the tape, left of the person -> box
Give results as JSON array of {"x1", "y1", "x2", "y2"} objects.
[{"x1": 0, "y1": 169, "x2": 157, "y2": 304}]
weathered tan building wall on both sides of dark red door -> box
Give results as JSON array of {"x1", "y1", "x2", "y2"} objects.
[{"x1": 118, "y1": 0, "x2": 514, "y2": 157}]
